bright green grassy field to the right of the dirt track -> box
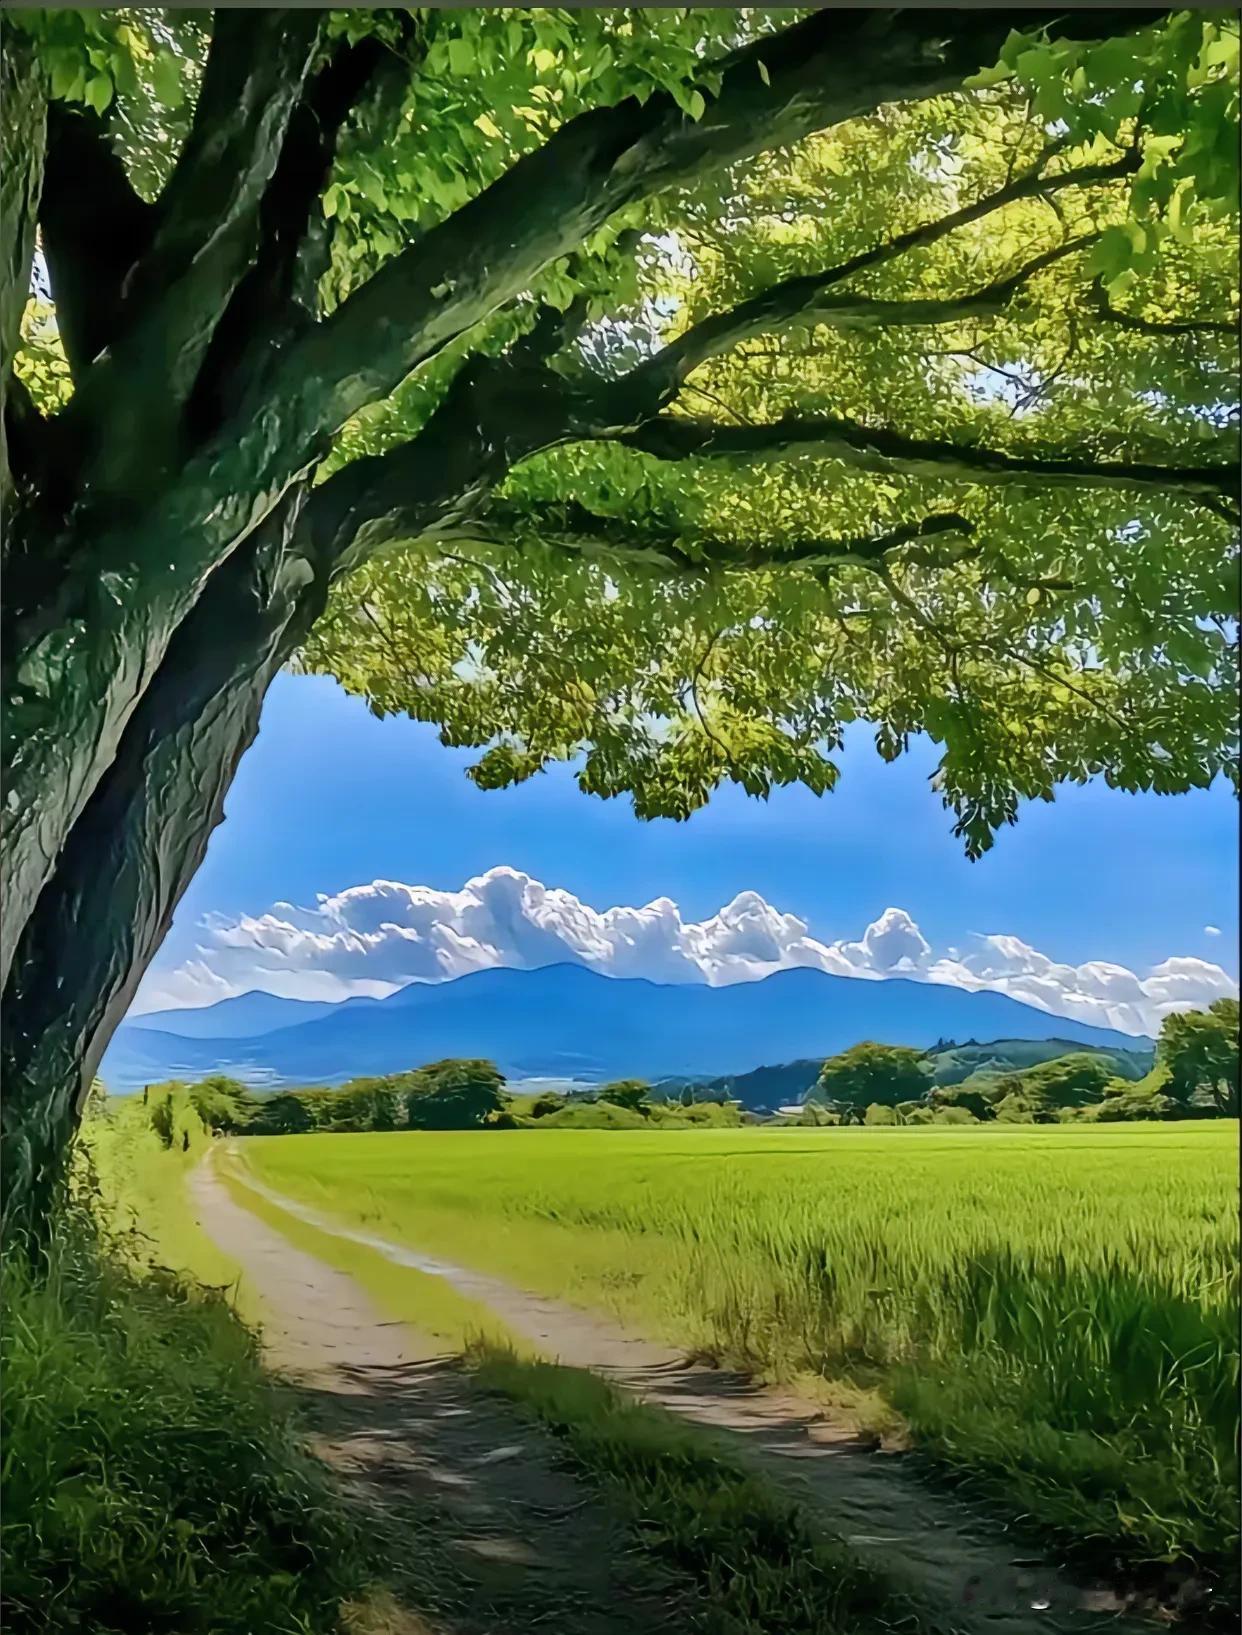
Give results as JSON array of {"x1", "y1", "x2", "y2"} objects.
[{"x1": 242, "y1": 1122, "x2": 1239, "y2": 1571}]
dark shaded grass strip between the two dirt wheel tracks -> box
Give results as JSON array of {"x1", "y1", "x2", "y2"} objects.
[{"x1": 467, "y1": 1346, "x2": 941, "y2": 1635}]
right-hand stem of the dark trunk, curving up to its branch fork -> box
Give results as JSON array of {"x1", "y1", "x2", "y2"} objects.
[{"x1": 0, "y1": 361, "x2": 542, "y2": 1238}]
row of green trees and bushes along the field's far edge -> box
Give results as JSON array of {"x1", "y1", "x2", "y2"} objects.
[{"x1": 111, "y1": 999, "x2": 1239, "y2": 1143}]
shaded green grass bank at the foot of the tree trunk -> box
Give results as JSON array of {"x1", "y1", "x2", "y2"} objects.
[{"x1": 0, "y1": 1202, "x2": 376, "y2": 1635}]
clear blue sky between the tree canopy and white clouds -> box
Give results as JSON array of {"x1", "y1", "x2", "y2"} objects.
[{"x1": 142, "y1": 675, "x2": 1239, "y2": 1020}]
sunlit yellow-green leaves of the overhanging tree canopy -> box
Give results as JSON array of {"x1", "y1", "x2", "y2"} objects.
[{"x1": 7, "y1": 7, "x2": 1239, "y2": 857}]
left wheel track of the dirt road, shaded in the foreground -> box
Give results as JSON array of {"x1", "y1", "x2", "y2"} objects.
[{"x1": 190, "y1": 1166, "x2": 690, "y2": 1635}]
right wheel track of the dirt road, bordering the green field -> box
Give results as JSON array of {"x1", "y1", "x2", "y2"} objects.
[{"x1": 196, "y1": 1174, "x2": 1150, "y2": 1635}]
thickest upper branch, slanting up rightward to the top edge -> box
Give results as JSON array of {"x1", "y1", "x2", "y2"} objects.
[{"x1": 284, "y1": 8, "x2": 1154, "y2": 451}]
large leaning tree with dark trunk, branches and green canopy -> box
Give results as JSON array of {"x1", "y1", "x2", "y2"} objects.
[{"x1": 0, "y1": 8, "x2": 1237, "y2": 1213}]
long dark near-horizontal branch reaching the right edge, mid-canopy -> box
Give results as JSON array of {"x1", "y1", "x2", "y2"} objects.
[{"x1": 621, "y1": 415, "x2": 1237, "y2": 495}]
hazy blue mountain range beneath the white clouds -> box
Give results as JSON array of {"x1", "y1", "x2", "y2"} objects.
[{"x1": 100, "y1": 965, "x2": 1141, "y2": 1091}]
